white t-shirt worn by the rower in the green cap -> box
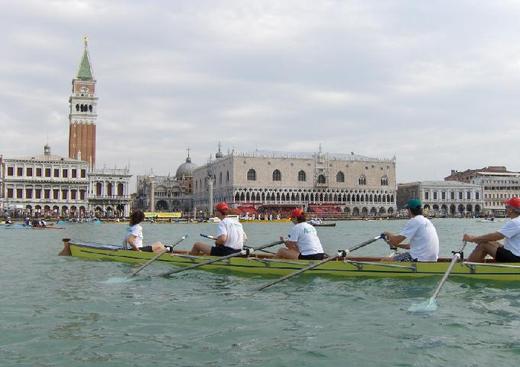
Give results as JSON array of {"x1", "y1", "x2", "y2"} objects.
[{"x1": 399, "y1": 215, "x2": 439, "y2": 261}]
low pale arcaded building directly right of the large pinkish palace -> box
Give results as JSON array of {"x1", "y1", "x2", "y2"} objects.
[{"x1": 397, "y1": 181, "x2": 484, "y2": 217}]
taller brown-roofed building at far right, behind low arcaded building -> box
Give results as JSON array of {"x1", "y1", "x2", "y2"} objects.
[{"x1": 445, "y1": 166, "x2": 520, "y2": 216}]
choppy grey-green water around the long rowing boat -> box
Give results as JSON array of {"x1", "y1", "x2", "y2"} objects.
[{"x1": 0, "y1": 219, "x2": 520, "y2": 367}]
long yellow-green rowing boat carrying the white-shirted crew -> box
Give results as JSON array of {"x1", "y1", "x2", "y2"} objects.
[{"x1": 60, "y1": 239, "x2": 520, "y2": 281}]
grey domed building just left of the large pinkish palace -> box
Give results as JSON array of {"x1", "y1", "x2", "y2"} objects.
[{"x1": 134, "y1": 152, "x2": 197, "y2": 212}]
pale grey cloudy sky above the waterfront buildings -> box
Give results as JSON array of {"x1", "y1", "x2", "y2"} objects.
[{"x1": 0, "y1": 0, "x2": 520, "y2": 182}]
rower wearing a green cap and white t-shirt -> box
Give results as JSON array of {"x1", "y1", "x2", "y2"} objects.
[{"x1": 385, "y1": 199, "x2": 439, "y2": 261}]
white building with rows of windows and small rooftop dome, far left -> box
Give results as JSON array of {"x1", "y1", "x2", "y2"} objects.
[{"x1": 2, "y1": 145, "x2": 89, "y2": 216}]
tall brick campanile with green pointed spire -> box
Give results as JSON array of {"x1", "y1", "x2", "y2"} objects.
[{"x1": 69, "y1": 37, "x2": 97, "y2": 169}]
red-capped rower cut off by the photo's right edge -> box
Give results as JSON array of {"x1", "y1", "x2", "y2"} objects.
[{"x1": 462, "y1": 197, "x2": 520, "y2": 262}]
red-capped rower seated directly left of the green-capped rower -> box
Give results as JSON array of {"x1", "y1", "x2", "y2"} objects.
[{"x1": 275, "y1": 208, "x2": 326, "y2": 260}]
